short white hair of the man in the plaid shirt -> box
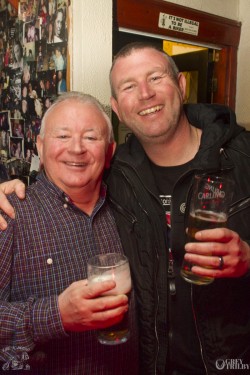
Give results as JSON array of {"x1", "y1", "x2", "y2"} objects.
[{"x1": 40, "y1": 91, "x2": 114, "y2": 143}]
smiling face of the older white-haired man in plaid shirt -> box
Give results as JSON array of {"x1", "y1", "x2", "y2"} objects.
[{"x1": 37, "y1": 99, "x2": 114, "y2": 196}]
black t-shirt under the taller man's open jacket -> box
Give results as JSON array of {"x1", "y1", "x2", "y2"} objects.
[{"x1": 150, "y1": 162, "x2": 205, "y2": 375}]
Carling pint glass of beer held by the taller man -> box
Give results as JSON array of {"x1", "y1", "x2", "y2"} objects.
[{"x1": 181, "y1": 174, "x2": 233, "y2": 285}]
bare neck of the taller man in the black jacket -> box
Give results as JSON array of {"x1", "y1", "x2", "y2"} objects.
[{"x1": 143, "y1": 121, "x2": 201, "y2": 167}]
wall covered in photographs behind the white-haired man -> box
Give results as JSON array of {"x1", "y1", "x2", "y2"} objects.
[{"x1": 0, "y1": 0, "x2": 69, "y2": 184}]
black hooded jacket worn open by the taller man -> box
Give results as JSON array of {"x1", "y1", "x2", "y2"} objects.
[{"x1": 107, "y1": 104, "x2": 250, "y2": 375}]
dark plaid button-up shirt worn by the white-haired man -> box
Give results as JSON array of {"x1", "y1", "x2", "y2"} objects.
[{"x1": 0, "y1": 173, "x2": 137, "y2": 375}]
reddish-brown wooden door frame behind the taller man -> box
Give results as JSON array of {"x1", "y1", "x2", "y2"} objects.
[{"x1": 114, "y1": 0, "x2": 241, "y2": 109}]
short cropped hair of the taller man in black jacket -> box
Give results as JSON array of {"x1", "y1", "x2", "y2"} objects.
[{"x1": 109, "y1": 42, "x2": 179, "y2": 98}]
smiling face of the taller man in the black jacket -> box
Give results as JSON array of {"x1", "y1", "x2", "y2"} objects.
[{"x1": 111, "y1": 47, "x2": 185, "y2": 143}]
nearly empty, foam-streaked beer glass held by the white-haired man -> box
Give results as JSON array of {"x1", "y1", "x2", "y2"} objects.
[{"x1": 88, "y1": 253, "x2": 132, "y2": 345}]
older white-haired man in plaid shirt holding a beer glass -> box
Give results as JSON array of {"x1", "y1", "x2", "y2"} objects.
[{"x1": 0, "y1": 92, "x2": 137, "y2": 375}]
